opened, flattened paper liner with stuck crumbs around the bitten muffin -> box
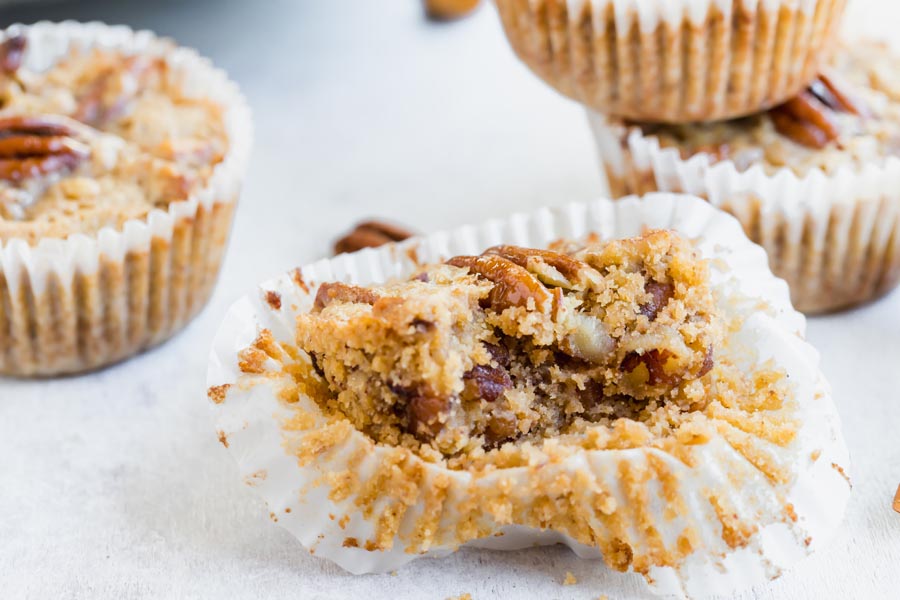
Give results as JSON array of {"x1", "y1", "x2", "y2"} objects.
[{"x1": 208, "y1": 194, "x2": 850, "y2": 596}]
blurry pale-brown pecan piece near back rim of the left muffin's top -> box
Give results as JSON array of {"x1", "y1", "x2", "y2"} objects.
[{"x1": 72, "y1": 56, "x2": 165, "y2": 127}]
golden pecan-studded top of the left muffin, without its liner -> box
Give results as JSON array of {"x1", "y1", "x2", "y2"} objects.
[{"x1": 0, "y1": 31, "x2": 228, "y2": 245}]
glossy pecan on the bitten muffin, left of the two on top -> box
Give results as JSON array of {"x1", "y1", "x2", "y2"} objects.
[{"x1": 447, "y1": 255, "x2": 553, "y2": 312}]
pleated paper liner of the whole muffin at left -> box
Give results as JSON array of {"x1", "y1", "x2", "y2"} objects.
[{"x1": 0, "y1": 22, "x2": 252, "y2": 376}]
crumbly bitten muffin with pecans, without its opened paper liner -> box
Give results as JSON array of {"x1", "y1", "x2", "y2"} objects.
[{"x1": 241, "y1": 231, "x2": 796, "y2": 468}]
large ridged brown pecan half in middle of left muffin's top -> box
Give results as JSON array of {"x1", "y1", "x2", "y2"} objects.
[{"x1": 0, "y1": 115, "x2": 90, "y2": 182}]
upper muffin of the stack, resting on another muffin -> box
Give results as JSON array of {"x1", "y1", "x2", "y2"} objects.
[{"x1": 496, "y1": 0, "x2": 845, "y2": 123}]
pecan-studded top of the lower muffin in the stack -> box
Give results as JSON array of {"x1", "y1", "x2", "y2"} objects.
[{"x1": 640, "y1": 41, "x2": 900, "y2": 176}]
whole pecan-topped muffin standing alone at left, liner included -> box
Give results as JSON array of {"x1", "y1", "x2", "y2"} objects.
[{"x1": 0, "y1": 22, "x2": 251, "y2": 376}]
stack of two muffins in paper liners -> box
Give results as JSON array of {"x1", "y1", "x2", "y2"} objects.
[{"x1": 497, "y1": 0, "x2": 900, "y2": 313}]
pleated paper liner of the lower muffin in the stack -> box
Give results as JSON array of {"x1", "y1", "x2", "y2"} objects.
[{"x1": 589, "y1": 113, "x2": 900, "y2": 313}]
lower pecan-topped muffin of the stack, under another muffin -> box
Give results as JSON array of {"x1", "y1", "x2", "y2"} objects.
[{"x1": 590, "y1": 41, "x2": 900, "y2": 313}]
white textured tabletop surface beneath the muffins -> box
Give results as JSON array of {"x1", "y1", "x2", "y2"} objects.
[{"x1": 0, "y1": 0, "x2": 900, "y2": 600}]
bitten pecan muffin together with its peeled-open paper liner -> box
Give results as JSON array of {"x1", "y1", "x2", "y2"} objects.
[{"x1": 208, "y1": 194, "x2": 849, "y2": 595}]
